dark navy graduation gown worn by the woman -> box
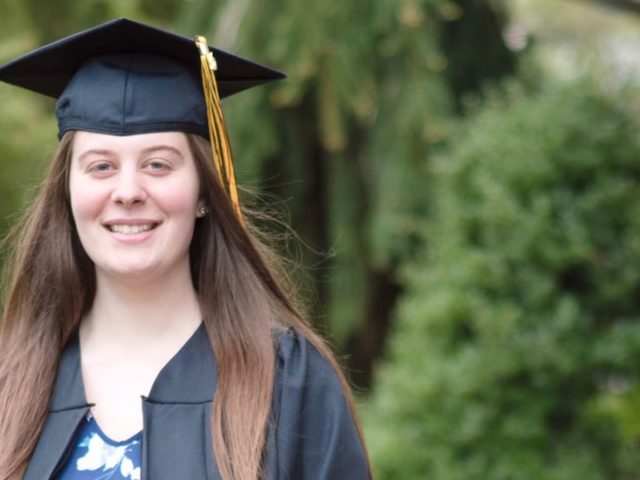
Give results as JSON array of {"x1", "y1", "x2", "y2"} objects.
[{"x1": 24, "y1": 326, "x2": 369, "y2": 480}]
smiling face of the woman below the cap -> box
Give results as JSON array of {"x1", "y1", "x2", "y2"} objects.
[{"x1": 69, "y1": 132, "x2": 199, "y2": 280}]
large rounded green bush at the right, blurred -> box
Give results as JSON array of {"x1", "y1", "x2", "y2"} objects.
[{"x1": 366, "y1": 83, "x2": 640, "y2": 480}]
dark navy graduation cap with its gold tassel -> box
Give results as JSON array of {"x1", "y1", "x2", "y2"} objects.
[{"x1": 0, "y1": 18, "x2": 284, "y2": 219}]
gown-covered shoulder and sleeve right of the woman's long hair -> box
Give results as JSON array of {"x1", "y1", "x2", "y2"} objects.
[{"x1": 270, "y1": 329, "x2": 369, "y2": 480}]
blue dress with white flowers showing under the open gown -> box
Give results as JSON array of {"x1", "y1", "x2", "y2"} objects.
[{"x1": 58, "y1": 414, "x2": 142, "y2": 480}]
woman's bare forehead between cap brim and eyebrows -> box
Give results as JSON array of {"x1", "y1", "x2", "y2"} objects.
[{"x1": 72, "y1": 131, "x2": 190, "y2": 157}]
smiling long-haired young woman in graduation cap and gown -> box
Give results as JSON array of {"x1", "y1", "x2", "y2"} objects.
[{"x1": 0, "y1": 19, "x2": 370, "y2": 480}]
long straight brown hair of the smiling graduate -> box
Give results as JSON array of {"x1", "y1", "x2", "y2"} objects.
[{"x1": 0, "y1": 132, "x2": 364, "y2": 480}]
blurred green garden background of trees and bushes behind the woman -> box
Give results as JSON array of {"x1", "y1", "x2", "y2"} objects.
[{"x1": 0, "y1": 0, "x2": 640, "y2": 480}]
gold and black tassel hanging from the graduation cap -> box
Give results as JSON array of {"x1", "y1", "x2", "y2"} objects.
[{"x1": 195, "y1": 36, "x2": 242, "y2": 222}]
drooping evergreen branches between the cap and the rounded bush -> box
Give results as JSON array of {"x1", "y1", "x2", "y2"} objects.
[{"x1": 222, "y1": 0, "x2": 451, "y2": 341}]
